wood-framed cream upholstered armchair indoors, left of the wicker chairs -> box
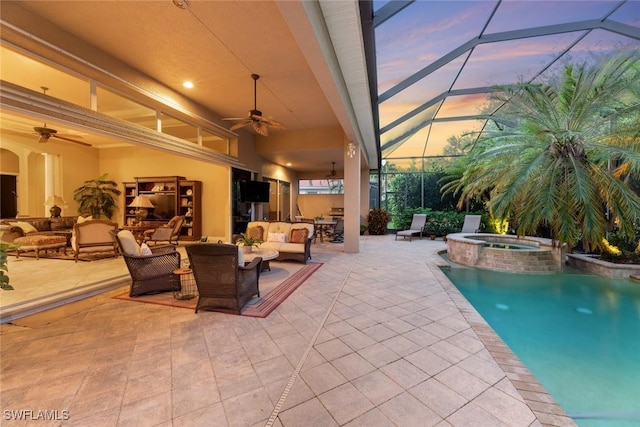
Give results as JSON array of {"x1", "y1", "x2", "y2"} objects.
[{"x1": 71, "y1": 219, "x2": 118, "y2": 262}]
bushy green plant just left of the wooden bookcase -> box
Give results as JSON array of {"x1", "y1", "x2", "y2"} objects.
[{"x1": 73, "y1": 173, "x2": 121, "y2": 219}]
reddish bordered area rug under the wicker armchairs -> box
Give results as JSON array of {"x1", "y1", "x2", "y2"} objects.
[{"x1": 113, "y1": 262, "x2": 322, "y2": 318}]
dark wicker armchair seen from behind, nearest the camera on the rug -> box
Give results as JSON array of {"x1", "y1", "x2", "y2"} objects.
[{"x1": 186, "y1": 243, "x2": 262, "y2": 314}]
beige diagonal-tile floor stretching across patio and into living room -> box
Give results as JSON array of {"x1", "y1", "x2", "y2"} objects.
[{"x1": 0, "y1": 235, "x2": 575, "y2": 427}]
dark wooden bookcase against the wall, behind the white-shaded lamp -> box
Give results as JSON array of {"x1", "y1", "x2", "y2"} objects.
[{"x1": 122, "y1": 176, "x2": 202, "y2": 240}]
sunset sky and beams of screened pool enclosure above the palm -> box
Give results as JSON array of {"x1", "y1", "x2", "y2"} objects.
[{"x1": 373, "y1": 0, "x2": 640, "y2": 169}]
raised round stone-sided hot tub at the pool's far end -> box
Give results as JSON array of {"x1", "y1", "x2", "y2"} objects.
[{"x1": 447, "y1": 233, "x2": 564, "y2": 273}]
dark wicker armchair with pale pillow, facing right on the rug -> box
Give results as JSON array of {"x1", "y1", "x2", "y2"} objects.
[{"x1": 110, "y1": 231, "x2": 180, "y2": 297}]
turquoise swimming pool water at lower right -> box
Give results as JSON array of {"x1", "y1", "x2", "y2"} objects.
[{"x1": 445, "y1": 265, "x2": 640, "y2": 427}]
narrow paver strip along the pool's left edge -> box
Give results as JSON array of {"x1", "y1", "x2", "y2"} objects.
[{"x1": 434, "y1": 250, "x2": 577, "y2": 426}]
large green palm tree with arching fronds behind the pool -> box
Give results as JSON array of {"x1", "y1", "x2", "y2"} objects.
[{"x1": 446, "y1": 55, "x2": 640, "y2": 250}]
